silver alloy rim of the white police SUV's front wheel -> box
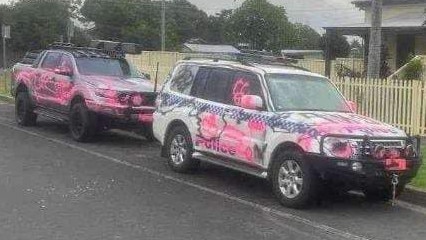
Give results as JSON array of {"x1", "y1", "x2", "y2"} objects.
[{"x1": 278, "y1": 160, "x2": 303, "y2": 199}]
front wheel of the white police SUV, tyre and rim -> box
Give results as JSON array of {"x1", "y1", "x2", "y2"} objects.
[{"x1": 271, "y1": 151, "x2": 319, "y2": 208}]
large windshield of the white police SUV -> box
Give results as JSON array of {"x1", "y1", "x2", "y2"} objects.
[{"x1": 266, "y1": 74, "x2": 350, "y2": 112}]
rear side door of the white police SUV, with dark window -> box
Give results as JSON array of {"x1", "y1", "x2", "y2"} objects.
[{"x1": 190, "y1": 67, "x2": 241, "y2": 158}]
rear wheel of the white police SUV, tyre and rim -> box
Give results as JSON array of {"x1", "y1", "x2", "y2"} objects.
[{"x1": 165, "y1": 126, "x2": 200, "y2": 173}]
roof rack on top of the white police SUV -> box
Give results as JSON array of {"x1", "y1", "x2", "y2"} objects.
[{"x1": 184, "y1": 53, "x2": 310, "y2": 72}]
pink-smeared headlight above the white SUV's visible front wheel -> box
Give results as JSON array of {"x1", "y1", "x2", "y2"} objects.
[{"x1": 323, "y1": 137, "x2": 357, "y2": 159}]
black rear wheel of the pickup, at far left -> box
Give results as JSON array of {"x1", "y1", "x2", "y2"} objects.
[{"x1": 15, "y1": 92, "x2": 37, "y2": 126}]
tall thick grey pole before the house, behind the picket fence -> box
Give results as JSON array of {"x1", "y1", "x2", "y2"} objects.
[{"x1": 367, "y1": 0, "x2": 383, "y2": 79}]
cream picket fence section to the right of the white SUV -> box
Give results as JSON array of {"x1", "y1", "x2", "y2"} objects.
[{"x1": 332, "y1": 78, "x2": 426, "y2": 136}]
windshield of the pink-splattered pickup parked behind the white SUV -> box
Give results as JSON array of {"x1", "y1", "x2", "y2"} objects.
[{"x1": 76, "y1": 57, "x2": 141, "y2": 77}]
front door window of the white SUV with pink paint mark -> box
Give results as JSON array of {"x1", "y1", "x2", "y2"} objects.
[{"x1": 229, "y1": 71, "x2": 264, "y2": 106}]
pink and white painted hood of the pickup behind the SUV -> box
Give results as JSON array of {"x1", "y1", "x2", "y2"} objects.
[{"x1": 82, "y1": 76, "x2": 154, "y2": 92}]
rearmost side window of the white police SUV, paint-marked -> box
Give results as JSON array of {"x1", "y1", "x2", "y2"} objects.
[{"x1": 170, "y1": 65, "x2": 198, "y2": 95}]
